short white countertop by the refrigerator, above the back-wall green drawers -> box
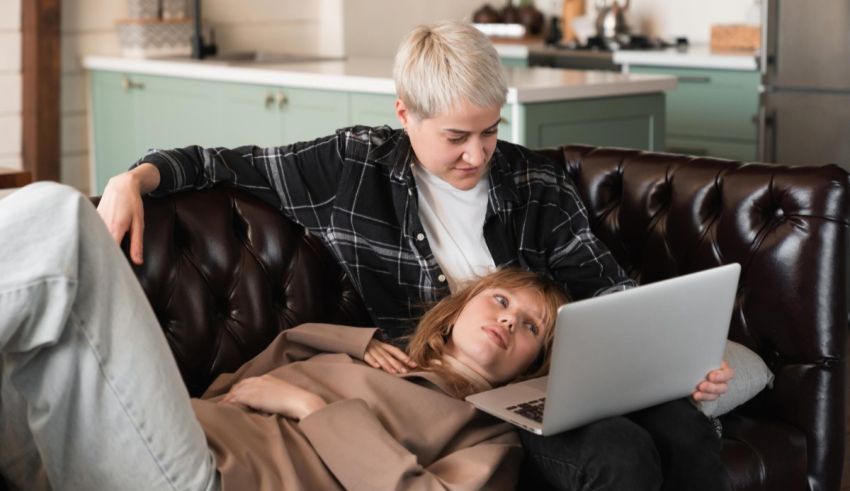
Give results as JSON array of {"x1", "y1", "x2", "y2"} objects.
[{"x1": 614, "y1": 45, "x2": 758, "y2": 71}]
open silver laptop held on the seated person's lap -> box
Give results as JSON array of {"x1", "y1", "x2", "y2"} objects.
[{"x1": 466, "y1": 264, "x2": 741, "y2": 435}]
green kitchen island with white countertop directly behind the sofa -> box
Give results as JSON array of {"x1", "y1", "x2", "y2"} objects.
[{"x1": 84, "y1": 57, "x2": 676, "y2": 193}]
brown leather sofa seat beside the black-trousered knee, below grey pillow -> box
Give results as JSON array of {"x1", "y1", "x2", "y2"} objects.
[{"x1": 720, "y1": 413, "x2": 808, "y2": 491}]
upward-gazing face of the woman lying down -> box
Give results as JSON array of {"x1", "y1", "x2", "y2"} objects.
[{"x1": 446, "y1": 288, "x2": 551, "y2": 385}]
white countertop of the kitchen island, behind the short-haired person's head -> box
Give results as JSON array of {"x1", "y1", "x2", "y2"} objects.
[{"x1": 83, "y1": 56, "x2": 676, "y2": 103}]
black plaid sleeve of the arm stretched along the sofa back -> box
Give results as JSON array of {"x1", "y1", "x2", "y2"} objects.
[{"x1": 133, "y1": 130, "x2": 346, "y2": 228}]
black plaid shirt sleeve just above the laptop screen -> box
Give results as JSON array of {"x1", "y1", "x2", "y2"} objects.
[{"x1": 547, "y1": 169, "x2": 635, "y2": 300}]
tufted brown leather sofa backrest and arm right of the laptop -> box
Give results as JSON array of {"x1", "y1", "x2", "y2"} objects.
[{"x1": 543, "y1": 146, "x2": 850, "y2": 489}]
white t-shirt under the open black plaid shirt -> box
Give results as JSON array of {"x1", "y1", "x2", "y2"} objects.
[{"x1": 413, "y1": 164, "x2": 496, "y2": 292}]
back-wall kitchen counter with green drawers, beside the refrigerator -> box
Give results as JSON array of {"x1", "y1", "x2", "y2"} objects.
[{"x1": 494, "y1": 41, "x2": 761, "y2": 161}]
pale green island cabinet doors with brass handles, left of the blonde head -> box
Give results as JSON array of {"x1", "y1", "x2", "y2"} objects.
[{"x1": 91, "y1": 71, "x2": 349, "y2": 193}]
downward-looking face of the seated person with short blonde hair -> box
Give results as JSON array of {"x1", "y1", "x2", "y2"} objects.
[{"x1": 396, "y1": 99, "x2": 501, "y2": 190}]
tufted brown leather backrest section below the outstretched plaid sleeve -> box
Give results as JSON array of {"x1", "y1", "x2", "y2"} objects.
[{"x1": 123, "y1": 187, "x2": 370, "y2": 396}]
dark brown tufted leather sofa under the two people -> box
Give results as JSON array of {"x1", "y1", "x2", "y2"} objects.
[{"x1": 4, "y1": 146, "x2": 850, "y2": 491}]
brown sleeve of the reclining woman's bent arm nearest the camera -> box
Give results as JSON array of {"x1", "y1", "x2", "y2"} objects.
[{"x1": 299, "y1": 399, "x2": 522, "y2": 490}]
